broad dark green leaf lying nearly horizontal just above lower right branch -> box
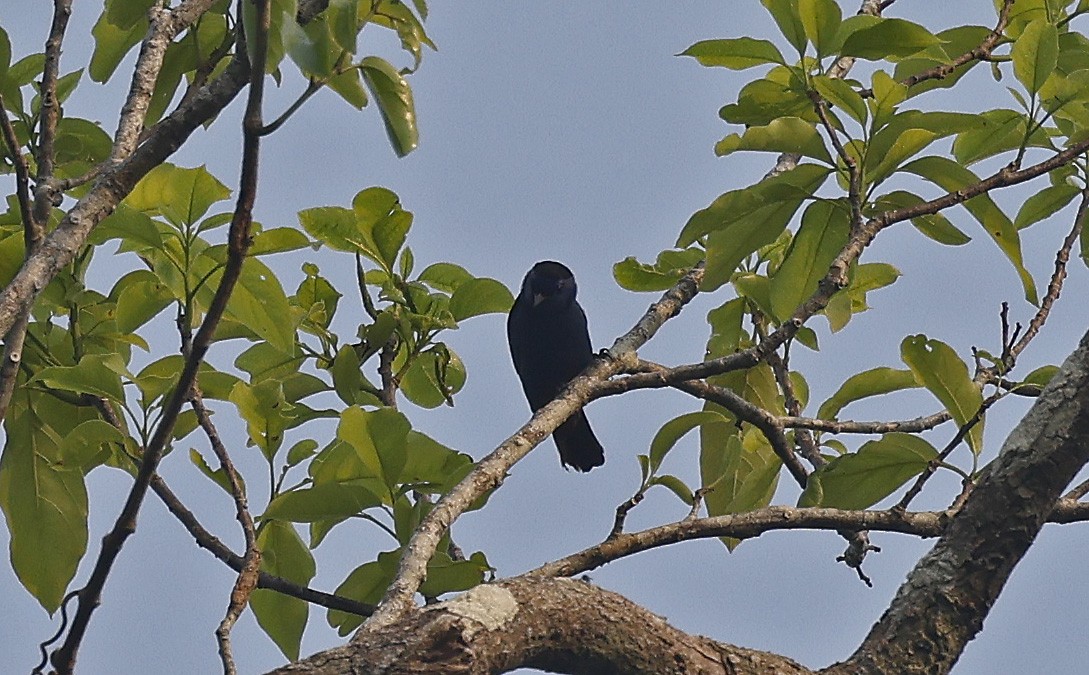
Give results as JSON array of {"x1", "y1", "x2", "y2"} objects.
[{"x1": 798, "y1": 433, "x2": 938, "y2": 511}]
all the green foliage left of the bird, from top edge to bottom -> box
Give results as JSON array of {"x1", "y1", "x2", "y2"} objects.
[{"x1": 0, "y1": 0, "x2": 513, "y2": 659}]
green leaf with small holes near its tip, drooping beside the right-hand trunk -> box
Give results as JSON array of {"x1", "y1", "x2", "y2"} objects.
[{"x1": 900, "y1": 334, "x2": 983, "y2": 455}]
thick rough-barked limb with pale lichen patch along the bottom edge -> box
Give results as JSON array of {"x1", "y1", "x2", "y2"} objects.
[{"x1": 274, "y1": 578, "x2": 812, "y2": 675}]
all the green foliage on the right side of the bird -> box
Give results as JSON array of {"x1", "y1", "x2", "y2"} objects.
[{"x1": 614, "y1": 0, "x2": 1089, "y2": 537}]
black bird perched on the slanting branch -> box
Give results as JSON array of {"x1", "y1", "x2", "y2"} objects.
[{"x1": 506, "y1": 260, "x2": 605, "y2": 471}]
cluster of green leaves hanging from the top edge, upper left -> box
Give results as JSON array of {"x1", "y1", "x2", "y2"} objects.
[{"x1": 90, "y1": 0, "x2": 435, "y2": 156}]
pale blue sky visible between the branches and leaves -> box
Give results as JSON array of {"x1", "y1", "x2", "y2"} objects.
[{"x1": 0, "y1": 0, "x2": 1089, "y2": 675}]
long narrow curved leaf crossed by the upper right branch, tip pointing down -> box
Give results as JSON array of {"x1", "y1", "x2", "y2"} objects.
[{"x1": 904, "y1": 157, "x2": 1039, "y2": 305}]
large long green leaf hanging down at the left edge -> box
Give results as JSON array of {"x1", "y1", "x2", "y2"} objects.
[{"x1": 0, "y1": 412, "x2": 87, "y2": 614}]
